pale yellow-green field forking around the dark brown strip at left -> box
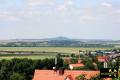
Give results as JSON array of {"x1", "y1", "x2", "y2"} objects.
[{"x1": 0, "y1": 47, "x2": 111, "y2": 59}]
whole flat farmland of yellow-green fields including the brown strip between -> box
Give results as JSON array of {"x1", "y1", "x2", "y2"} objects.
[{"x1": 0, "y1": 47, "x2": 112, "y2": 59}]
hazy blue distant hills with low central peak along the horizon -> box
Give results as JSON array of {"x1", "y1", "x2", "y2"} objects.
[{"x1": 0, "y1": 37, "x2": 120, "y2": 47}]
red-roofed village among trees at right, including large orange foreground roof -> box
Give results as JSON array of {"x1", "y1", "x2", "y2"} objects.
[{"x1": 33, "y1": 49, "x2": 120, "y2": 80}]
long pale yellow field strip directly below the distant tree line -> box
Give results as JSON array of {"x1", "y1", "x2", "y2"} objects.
[{"x1": 0, "y1": 47, "x2": 111, "y2": 53}]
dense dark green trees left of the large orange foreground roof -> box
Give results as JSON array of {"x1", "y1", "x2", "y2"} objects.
[{"x1": 0, "y1": 58, "x2": 63, "y2": 80}]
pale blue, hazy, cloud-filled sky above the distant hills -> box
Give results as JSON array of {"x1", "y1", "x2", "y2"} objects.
[{"x1": 0, "y1": 0, "x2": 120, "y2": 40}]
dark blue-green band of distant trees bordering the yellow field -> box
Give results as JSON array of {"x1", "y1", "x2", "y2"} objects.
[{"x1": 0, "y1": 41, "x2": 115, "y2": 48}]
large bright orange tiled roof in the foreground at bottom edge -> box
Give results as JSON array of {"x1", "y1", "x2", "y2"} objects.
[{"x1": 33, "y1": 70, "x2": 100, "y2": 80}]
